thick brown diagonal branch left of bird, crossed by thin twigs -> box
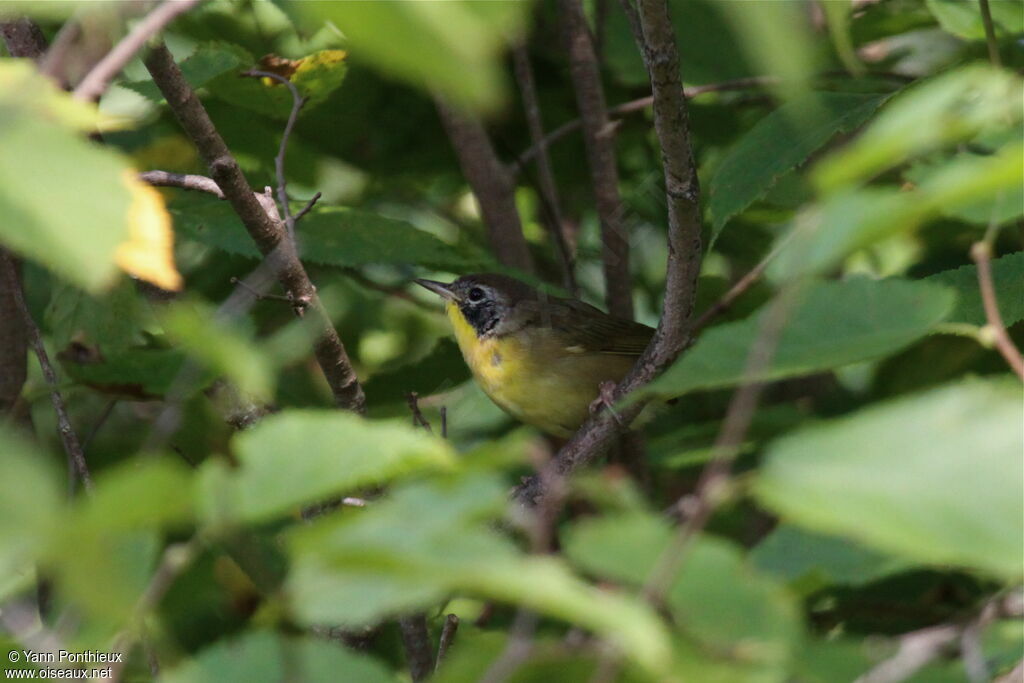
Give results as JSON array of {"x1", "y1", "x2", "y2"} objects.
[{"x1": 144, "y1": 43, "x2": 366, "y2": 414}]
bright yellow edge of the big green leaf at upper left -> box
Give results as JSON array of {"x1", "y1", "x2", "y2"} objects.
[{"x1": 114, "y1": 171, "x2": 182, "y2": 291}]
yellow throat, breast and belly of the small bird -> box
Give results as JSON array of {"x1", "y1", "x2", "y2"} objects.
[{"x1": 445, "y1": 301, "x2": 634, "y2": 437}]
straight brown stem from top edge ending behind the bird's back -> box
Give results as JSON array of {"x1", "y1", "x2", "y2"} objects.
[{"x1": 558, "y1": 0, "x2": 633, "y2": 318}]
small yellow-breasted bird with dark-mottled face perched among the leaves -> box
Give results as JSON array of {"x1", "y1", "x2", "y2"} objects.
[{"x1": 416, "y1": 272, "x2": 654, "y2": 438}]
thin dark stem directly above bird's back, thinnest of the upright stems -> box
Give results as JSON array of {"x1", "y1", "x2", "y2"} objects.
[{"x1": 512, "y1": 43, "x2": 579, "y2": 296}]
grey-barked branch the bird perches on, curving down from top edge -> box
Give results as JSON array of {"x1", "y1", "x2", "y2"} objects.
[{"x1": 515, "y1": 0, "x2": 700, "y2": 505}]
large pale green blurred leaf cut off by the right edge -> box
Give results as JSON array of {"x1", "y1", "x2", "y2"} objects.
[{"x1": 755, "y1": 380, "x2": 1024, "y2": 581}]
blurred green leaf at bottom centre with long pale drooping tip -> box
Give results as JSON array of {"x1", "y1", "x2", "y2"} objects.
[{"x1": 286, "y1": 475, "x2": 669, "y2": 676}]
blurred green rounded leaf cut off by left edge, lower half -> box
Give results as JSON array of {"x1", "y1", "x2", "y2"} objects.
[{"x1": 0, "y1": 424, "x2": 63, "y2": 577}]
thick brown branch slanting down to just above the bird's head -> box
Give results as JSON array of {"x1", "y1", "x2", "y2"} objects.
[{"x1": 436, "y1": 98, "x2": 534, "y2": 272}]
